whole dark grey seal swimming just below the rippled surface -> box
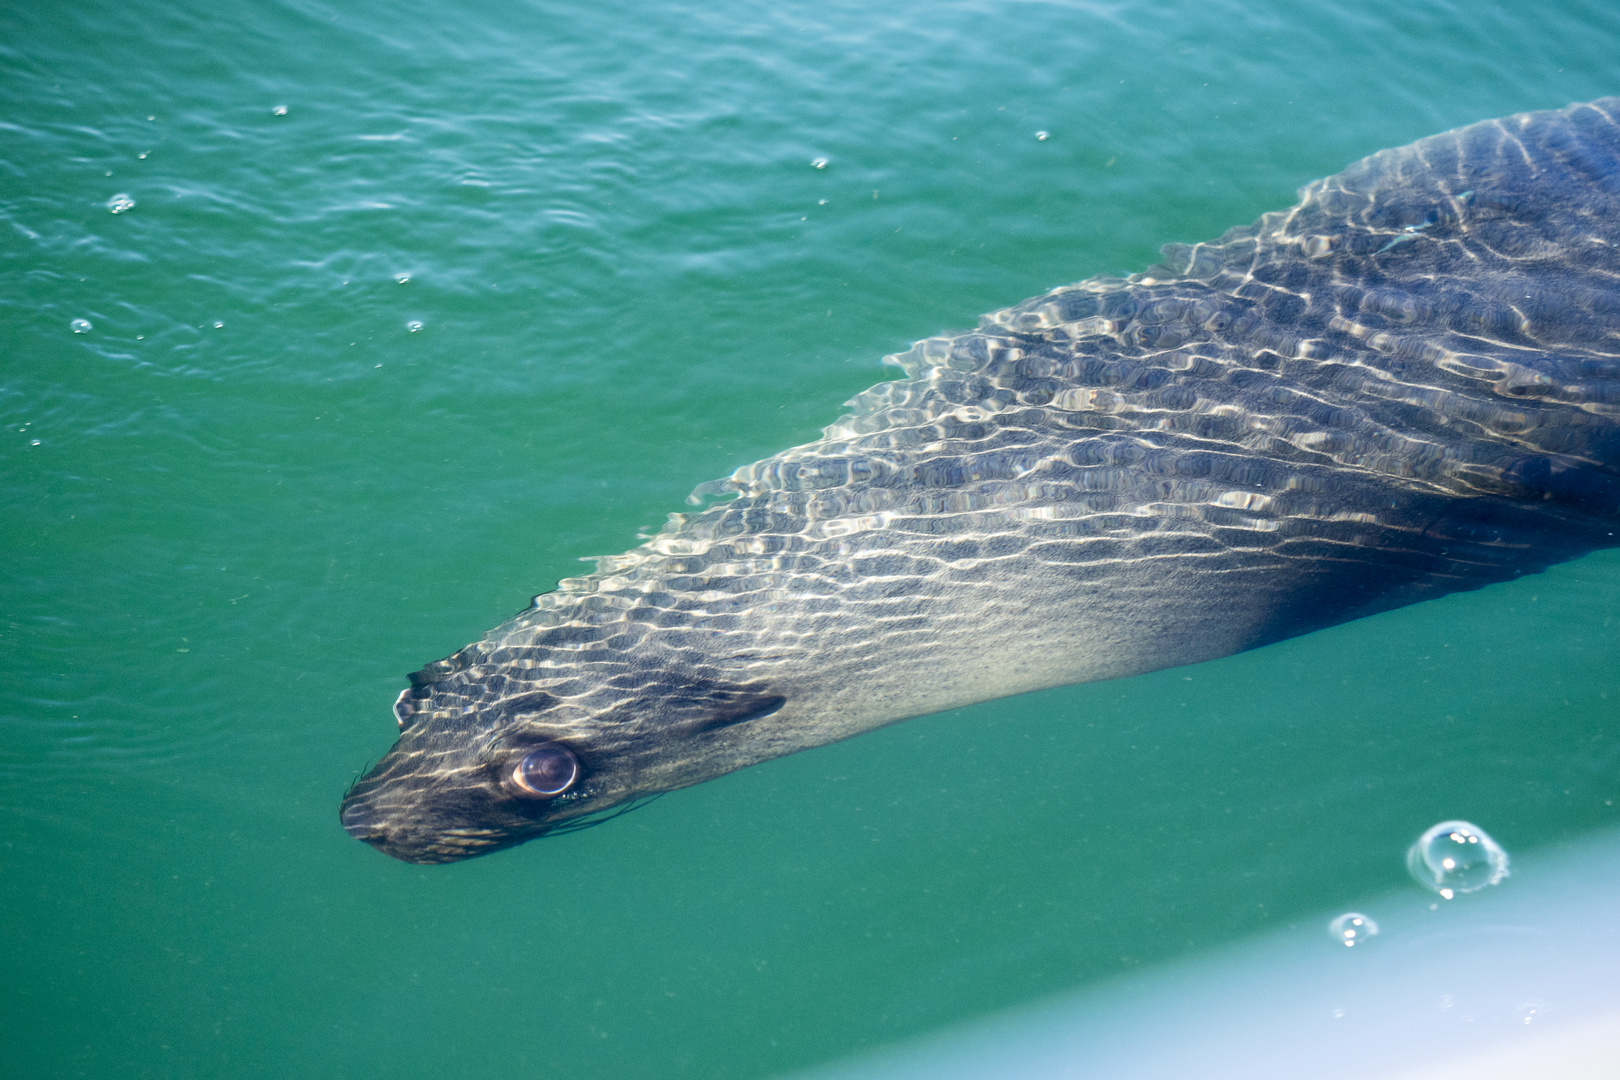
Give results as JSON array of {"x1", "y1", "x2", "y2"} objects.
[{"x1": 342, "y1": 99, "x2": 1620, "y2": 863}]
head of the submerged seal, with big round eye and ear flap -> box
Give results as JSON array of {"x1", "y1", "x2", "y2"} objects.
[{"x1": 342, "y1": 646, "x2": 784, "y2": 863}]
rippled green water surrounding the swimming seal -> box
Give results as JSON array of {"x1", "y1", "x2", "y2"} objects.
[{"x1": 9, "y1": 0, "x2": 1620, "y2": 1078}]
